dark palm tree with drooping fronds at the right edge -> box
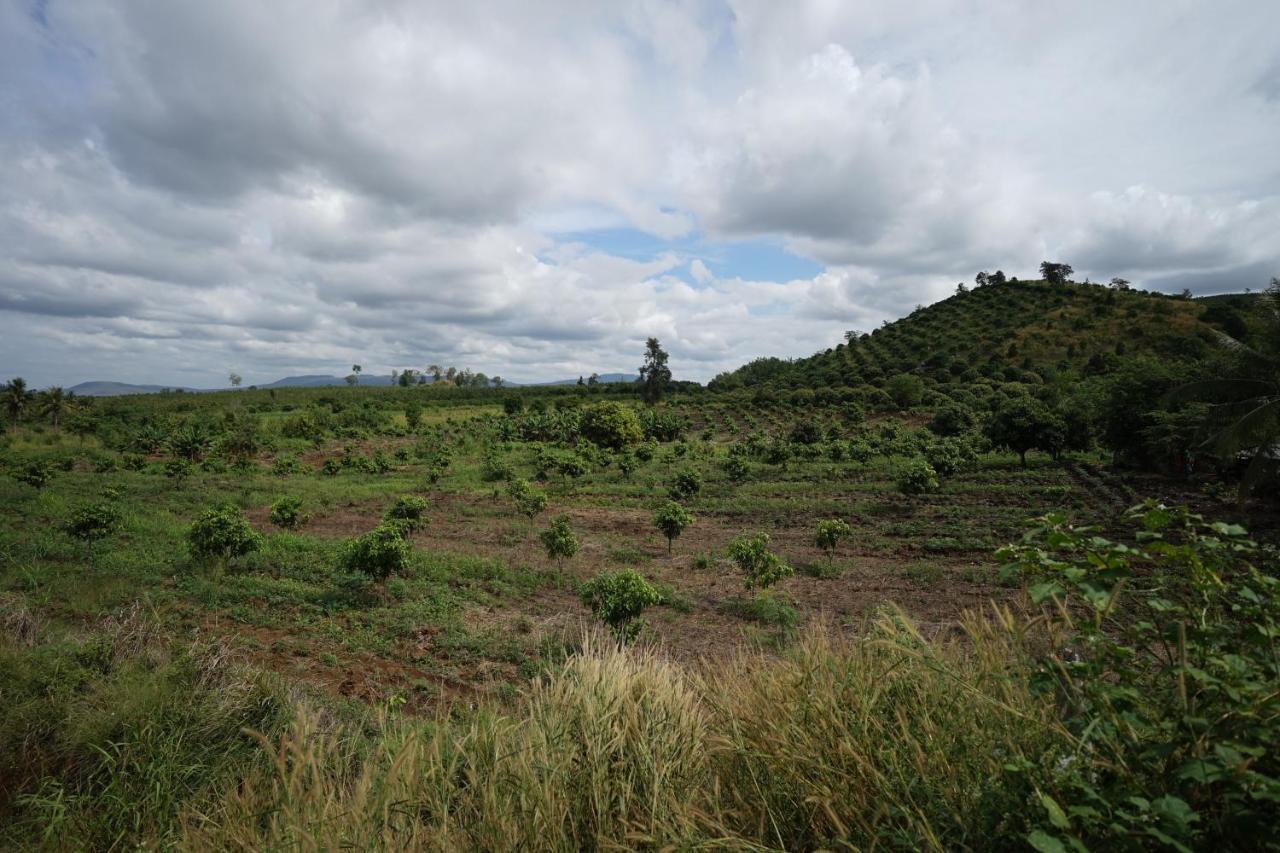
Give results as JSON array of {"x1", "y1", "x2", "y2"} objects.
[{"x1": 1167, "y1": 278, "x2": 1280, "y2": 497}]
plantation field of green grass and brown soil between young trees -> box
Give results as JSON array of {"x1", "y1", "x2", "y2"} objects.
[{"x1": 0, "y1": 386, "x2": 1268, "y2": 708}]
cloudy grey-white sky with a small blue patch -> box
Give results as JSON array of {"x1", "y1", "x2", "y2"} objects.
[{"x1": 0, "y1": 0, "x2": 1280, "y2": 387}]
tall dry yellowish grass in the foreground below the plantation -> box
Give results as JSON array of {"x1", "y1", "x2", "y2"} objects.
[{"x1": 183, "y1": 613, "x2": 1062, "y2": 850}]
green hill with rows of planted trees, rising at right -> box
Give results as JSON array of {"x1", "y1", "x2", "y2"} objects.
[{"x1": 710, "y1": 282, "x2": 1236, "y2": 391}]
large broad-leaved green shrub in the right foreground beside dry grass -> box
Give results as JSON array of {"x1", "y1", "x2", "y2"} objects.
[{"x1": 998, "y1": 502, "x2": 1280, "y2": 850}]
